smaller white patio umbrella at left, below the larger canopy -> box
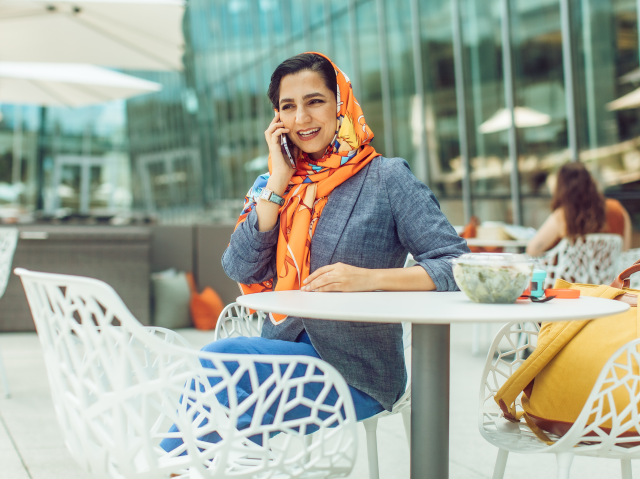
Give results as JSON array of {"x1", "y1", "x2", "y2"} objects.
[{"x1": 0, "y1": 62, "x2": 162, "y2": 107}]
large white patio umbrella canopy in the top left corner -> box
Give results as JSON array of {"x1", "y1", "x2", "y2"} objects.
[{"x1": 0, "y1": 0, "x2": 184, "y2": 70}]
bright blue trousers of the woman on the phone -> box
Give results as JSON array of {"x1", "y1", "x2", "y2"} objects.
[{"x1": 160, "y1": 331, "x2": 384, "y2": 451}]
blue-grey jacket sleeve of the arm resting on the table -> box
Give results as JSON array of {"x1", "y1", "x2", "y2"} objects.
[{"x1": 383, "y1": 158, "x2": 469, "y2": 291}]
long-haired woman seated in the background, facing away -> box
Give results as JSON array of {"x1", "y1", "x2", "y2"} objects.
[{"x1": 527, "y1": 162, "x2": 631, "y2": 256}]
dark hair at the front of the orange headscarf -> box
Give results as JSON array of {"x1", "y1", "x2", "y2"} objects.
[{"x1": 267, "y1": 53, "x2": 338, "y2": 110}]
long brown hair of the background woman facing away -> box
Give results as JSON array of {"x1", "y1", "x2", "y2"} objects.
[{"x1": 551, "y1": 162, "x2": 606, "y2": 240}]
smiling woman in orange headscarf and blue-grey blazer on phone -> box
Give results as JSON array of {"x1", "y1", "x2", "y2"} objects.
[{"x1": 165, "y1": 53, "x2": 468, "y2": 454}]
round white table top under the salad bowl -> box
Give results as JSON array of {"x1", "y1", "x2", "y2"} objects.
[{"x1": 236, "y1": 291, "x2": 629, "y2": 324}]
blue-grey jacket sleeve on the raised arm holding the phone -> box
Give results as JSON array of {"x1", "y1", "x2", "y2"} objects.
[{"x1": 222, "y1": 199, "x2": 280, "y2": 284}]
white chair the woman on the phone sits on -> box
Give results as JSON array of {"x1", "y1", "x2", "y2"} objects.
[{"x1": 214, "y1": 303, "x2": 411, "y2": 479}]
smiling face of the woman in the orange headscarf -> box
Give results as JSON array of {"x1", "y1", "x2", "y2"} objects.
[{"x1": 279, "y1": 70, "x2": 337, "y2": 160}]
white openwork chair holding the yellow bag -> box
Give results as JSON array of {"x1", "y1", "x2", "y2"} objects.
[{"x1": 478, "y1": 323, "x2": 640, "y2": 479}]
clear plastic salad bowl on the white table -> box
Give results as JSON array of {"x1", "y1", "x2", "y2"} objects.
[{"x1": 451, "y1": 253, "x2": 533, "y2": 303}]
